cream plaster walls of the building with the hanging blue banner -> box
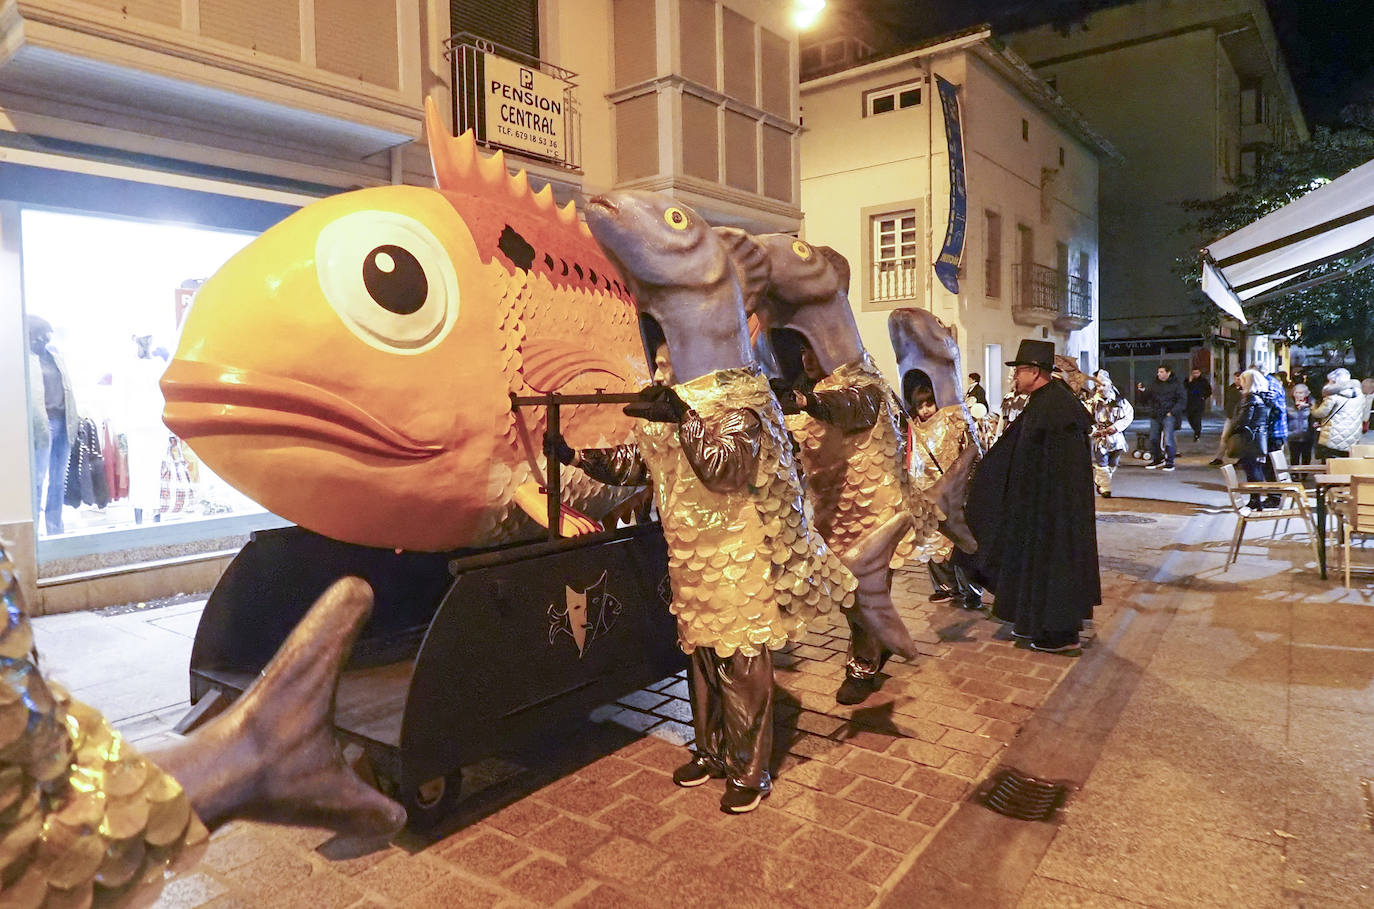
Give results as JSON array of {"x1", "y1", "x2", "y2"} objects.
[{"x1": 801, "y1": 52, "x2": 1099, "y2": 386}]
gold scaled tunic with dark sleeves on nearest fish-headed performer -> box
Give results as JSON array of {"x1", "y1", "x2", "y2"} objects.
[{"x1": 583, "y1": 368, "x2": 857, "y2": 658}]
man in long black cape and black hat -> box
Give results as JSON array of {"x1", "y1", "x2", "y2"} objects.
[{"x1": 966, "y1": 341, "x2": 1102, "y2": 656}]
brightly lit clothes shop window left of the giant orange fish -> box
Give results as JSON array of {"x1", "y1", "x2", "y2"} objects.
[{"x1": 21, "y1": 209, "x2": 262, "y2": 542}]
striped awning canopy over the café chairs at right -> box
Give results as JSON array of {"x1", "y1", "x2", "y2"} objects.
[{"x1": 1202, "y1": 161, "x2": 1374, "y2": 323}]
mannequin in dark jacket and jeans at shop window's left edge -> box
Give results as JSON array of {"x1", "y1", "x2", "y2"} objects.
[{"x1": 27, "y1": 316, "x2": 78, "y2": 536}]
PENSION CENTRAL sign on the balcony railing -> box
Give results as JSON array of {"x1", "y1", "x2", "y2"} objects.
[{"x1": 478, "y1": 54, "x2": 567, "y2": 161}]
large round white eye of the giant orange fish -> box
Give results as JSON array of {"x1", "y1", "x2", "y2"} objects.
[{"x1": 315, "y1": 211, "x2": 459, "y2": 354}]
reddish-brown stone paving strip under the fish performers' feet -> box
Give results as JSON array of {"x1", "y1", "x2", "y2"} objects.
[{"x1": 101, "y1": 527, "x2": 1136, "y2": 909}]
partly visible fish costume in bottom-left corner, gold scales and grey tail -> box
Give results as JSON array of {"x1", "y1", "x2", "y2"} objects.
[{"x1": 0, "y1": 546, "x2": 405, "y2": 909}]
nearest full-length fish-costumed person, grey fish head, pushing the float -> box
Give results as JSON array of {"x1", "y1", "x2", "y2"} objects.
[{"x1": 551, "y1": 192, "x2": 857, "y2": 813}]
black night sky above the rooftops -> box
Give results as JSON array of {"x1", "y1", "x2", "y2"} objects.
[{"x1": 862, "y1": 0, "x2": 1374, "y2": 126}]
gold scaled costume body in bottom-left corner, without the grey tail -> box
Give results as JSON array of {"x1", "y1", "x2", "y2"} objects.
[{"x1": 0, "y1": 549, "x2": 209, "y2": 909}]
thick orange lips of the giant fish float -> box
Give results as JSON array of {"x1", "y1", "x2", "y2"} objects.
[{"x1": 162, "y1": 360, "x2": 442, "y2": 460}]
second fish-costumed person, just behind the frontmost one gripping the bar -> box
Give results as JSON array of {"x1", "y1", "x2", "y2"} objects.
[{"x1": 719, "y1": 228, "x2": 943, "y2": 704}]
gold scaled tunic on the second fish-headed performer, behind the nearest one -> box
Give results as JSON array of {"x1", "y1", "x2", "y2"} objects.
[{"x1": 787, "y1": 354, "x2": 947, "y2": 568}]
